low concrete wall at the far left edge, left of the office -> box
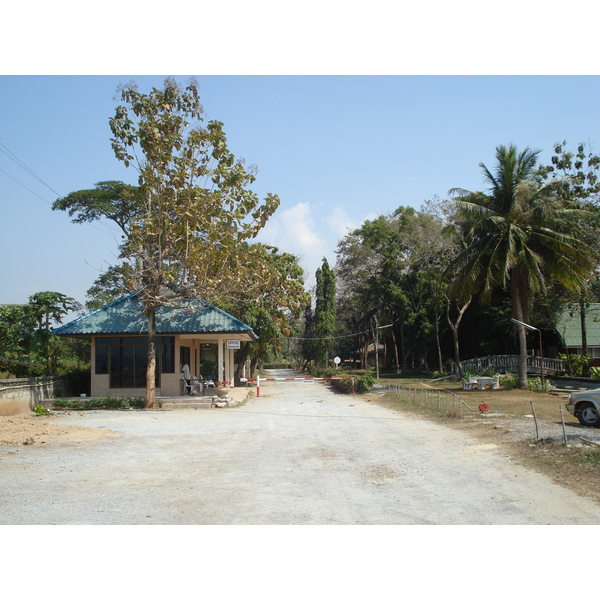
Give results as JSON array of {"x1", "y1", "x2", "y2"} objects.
[{"x1": 0, "y1": 377, "x2": 68, "y2": 417}]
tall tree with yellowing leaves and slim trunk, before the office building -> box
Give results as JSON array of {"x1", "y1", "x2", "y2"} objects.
[{"x1": 56, "y1": 79, "x2": 279, "y2": 407}]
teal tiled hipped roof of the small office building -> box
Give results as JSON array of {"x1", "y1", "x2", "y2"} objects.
[{"x1": 53, "y1": 294, "x2": 257, "y2": 340}]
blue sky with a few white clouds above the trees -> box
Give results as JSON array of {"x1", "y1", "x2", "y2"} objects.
[{"x1": 0, "y1": 75, "x2": 600, "y2": 303}]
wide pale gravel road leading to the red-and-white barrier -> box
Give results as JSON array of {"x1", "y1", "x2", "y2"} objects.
[{"x1": 0, "y1": 372, "x2": 600, "y2": 525}]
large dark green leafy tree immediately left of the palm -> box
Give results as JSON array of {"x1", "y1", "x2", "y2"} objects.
[{"x1": 336, "y1": 206, "x2": 449, "y2": 376}]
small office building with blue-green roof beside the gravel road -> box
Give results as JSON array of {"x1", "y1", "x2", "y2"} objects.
[{"x1": 53, "y1": 293, "x2": 258, "y2": 396}]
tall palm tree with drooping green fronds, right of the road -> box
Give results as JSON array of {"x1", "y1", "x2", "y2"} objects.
[{"x1": 449, "y1": 145, "x2": 595, "y2": 388}]
